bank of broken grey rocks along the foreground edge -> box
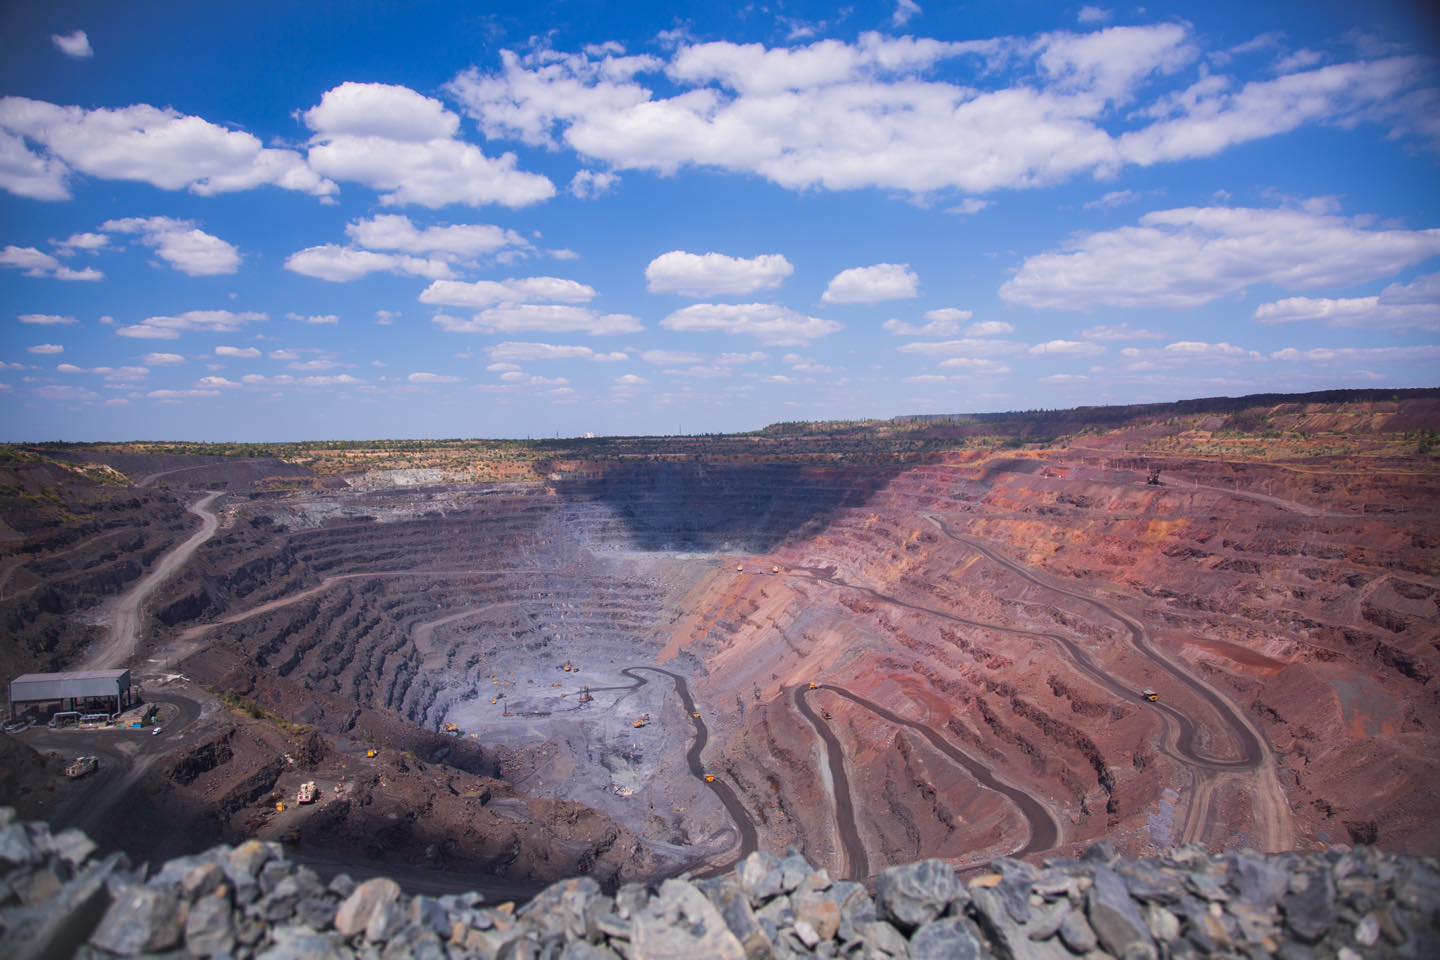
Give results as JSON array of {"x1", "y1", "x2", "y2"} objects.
[{"x1": 0, "y1": 809, "x2": 1440, "y2": 960}]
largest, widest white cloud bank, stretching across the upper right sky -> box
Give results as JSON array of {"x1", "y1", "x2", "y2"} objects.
[{"x1": 446, "y1": 29, "x2": 1434, "y2": 198}]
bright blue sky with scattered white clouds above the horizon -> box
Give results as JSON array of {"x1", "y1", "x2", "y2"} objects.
[{"x1": 0, "y1": 0, "x2": 1440, "y2": 440}]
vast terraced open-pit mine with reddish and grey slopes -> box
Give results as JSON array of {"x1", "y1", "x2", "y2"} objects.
[{"x1": 0, "y1": 390, "x2": 1440, "y2": 895}]
